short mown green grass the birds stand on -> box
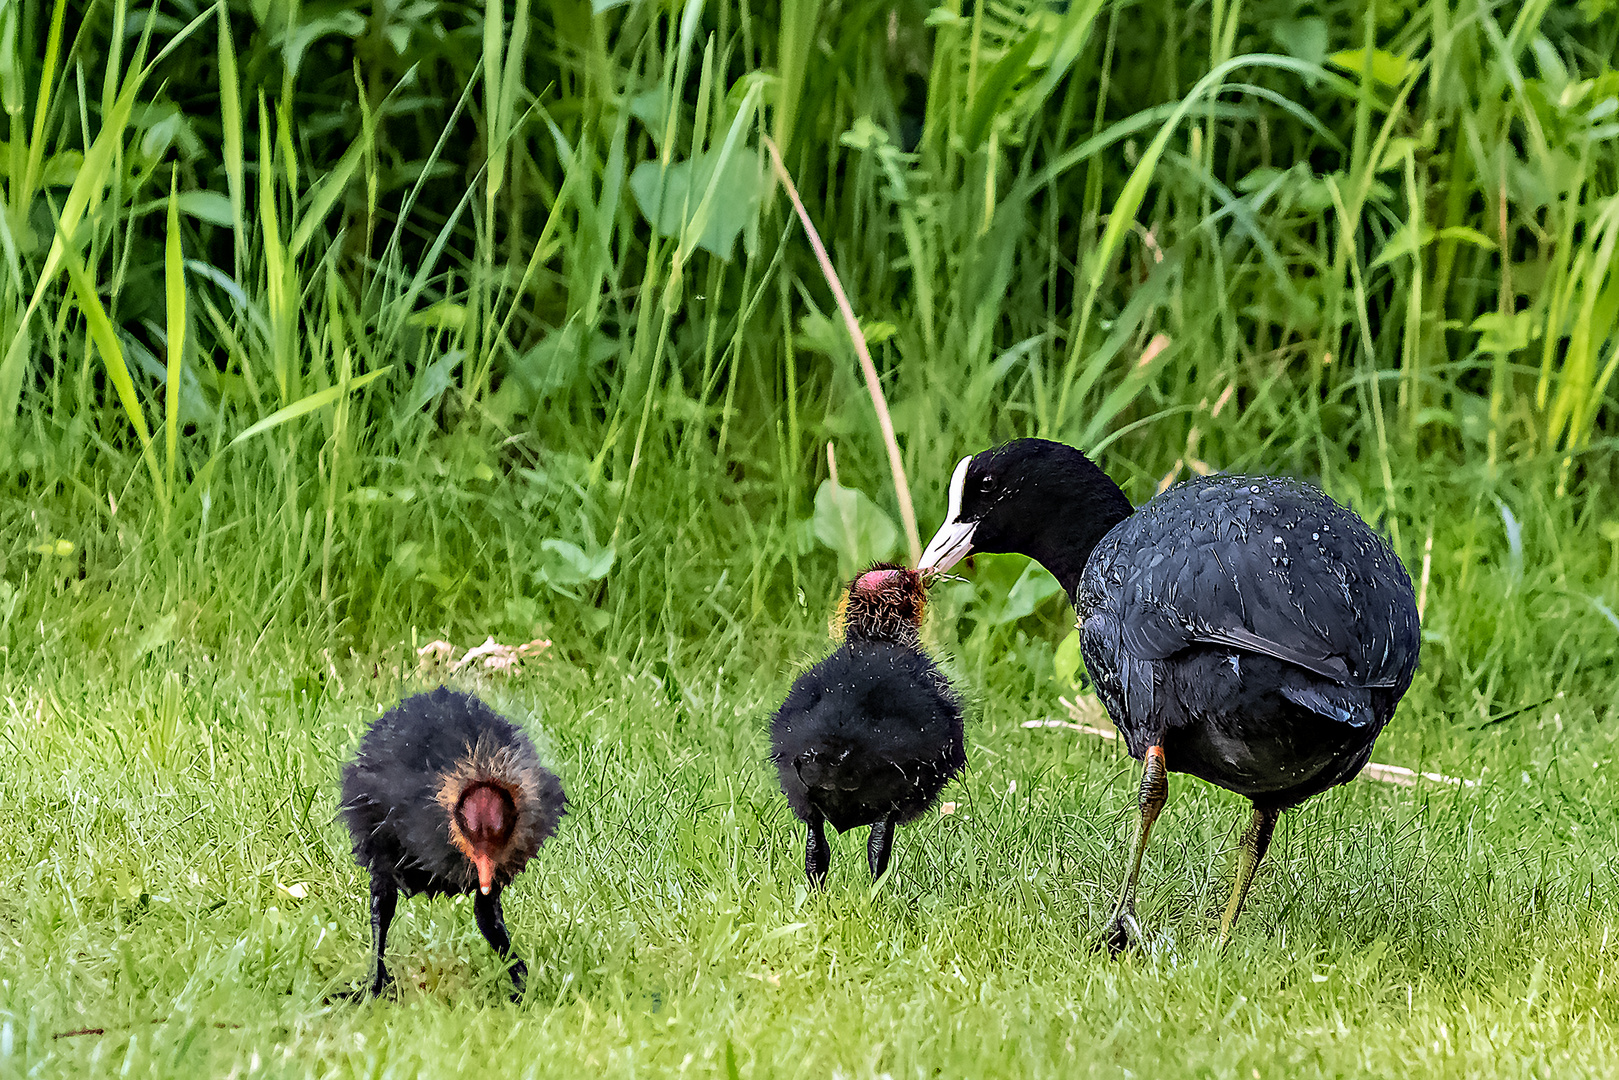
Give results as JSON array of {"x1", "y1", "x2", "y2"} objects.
[{"x1": 9, "y1": 461, "x2": 1619, "y2": 1077}]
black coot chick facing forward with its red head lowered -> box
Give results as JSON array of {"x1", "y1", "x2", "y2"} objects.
[{"x1": 338, "y1": 687, "x2": 567, "y2": 1001}]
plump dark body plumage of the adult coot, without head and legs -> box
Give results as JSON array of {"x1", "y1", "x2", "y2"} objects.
[{"x1": 1075, "y1": 476, "x2": 1418, "y2": 810}]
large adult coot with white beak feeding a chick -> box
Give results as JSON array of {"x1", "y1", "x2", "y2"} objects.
[{"x1": 920, "y1": 439, "x2": 1420, "y2": 952}]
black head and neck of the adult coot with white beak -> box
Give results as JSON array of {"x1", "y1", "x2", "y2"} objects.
[{"x1": 916, "y1": 439, "x2": 1130, "y2": 586}]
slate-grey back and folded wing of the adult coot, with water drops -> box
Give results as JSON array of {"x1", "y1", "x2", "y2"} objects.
[{"x1": 1081, "y1": 476, "x2": 1418, "y2": 690}]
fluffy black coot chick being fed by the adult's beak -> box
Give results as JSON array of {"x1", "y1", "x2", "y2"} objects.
[{"x1": 771, "y1": 565, "x2": 967, "y2": 886}]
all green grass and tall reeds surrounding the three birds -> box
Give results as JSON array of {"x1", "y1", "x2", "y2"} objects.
[{"x1": 0, "y1": 0, "x2": 1619, "y2": 1075}]
